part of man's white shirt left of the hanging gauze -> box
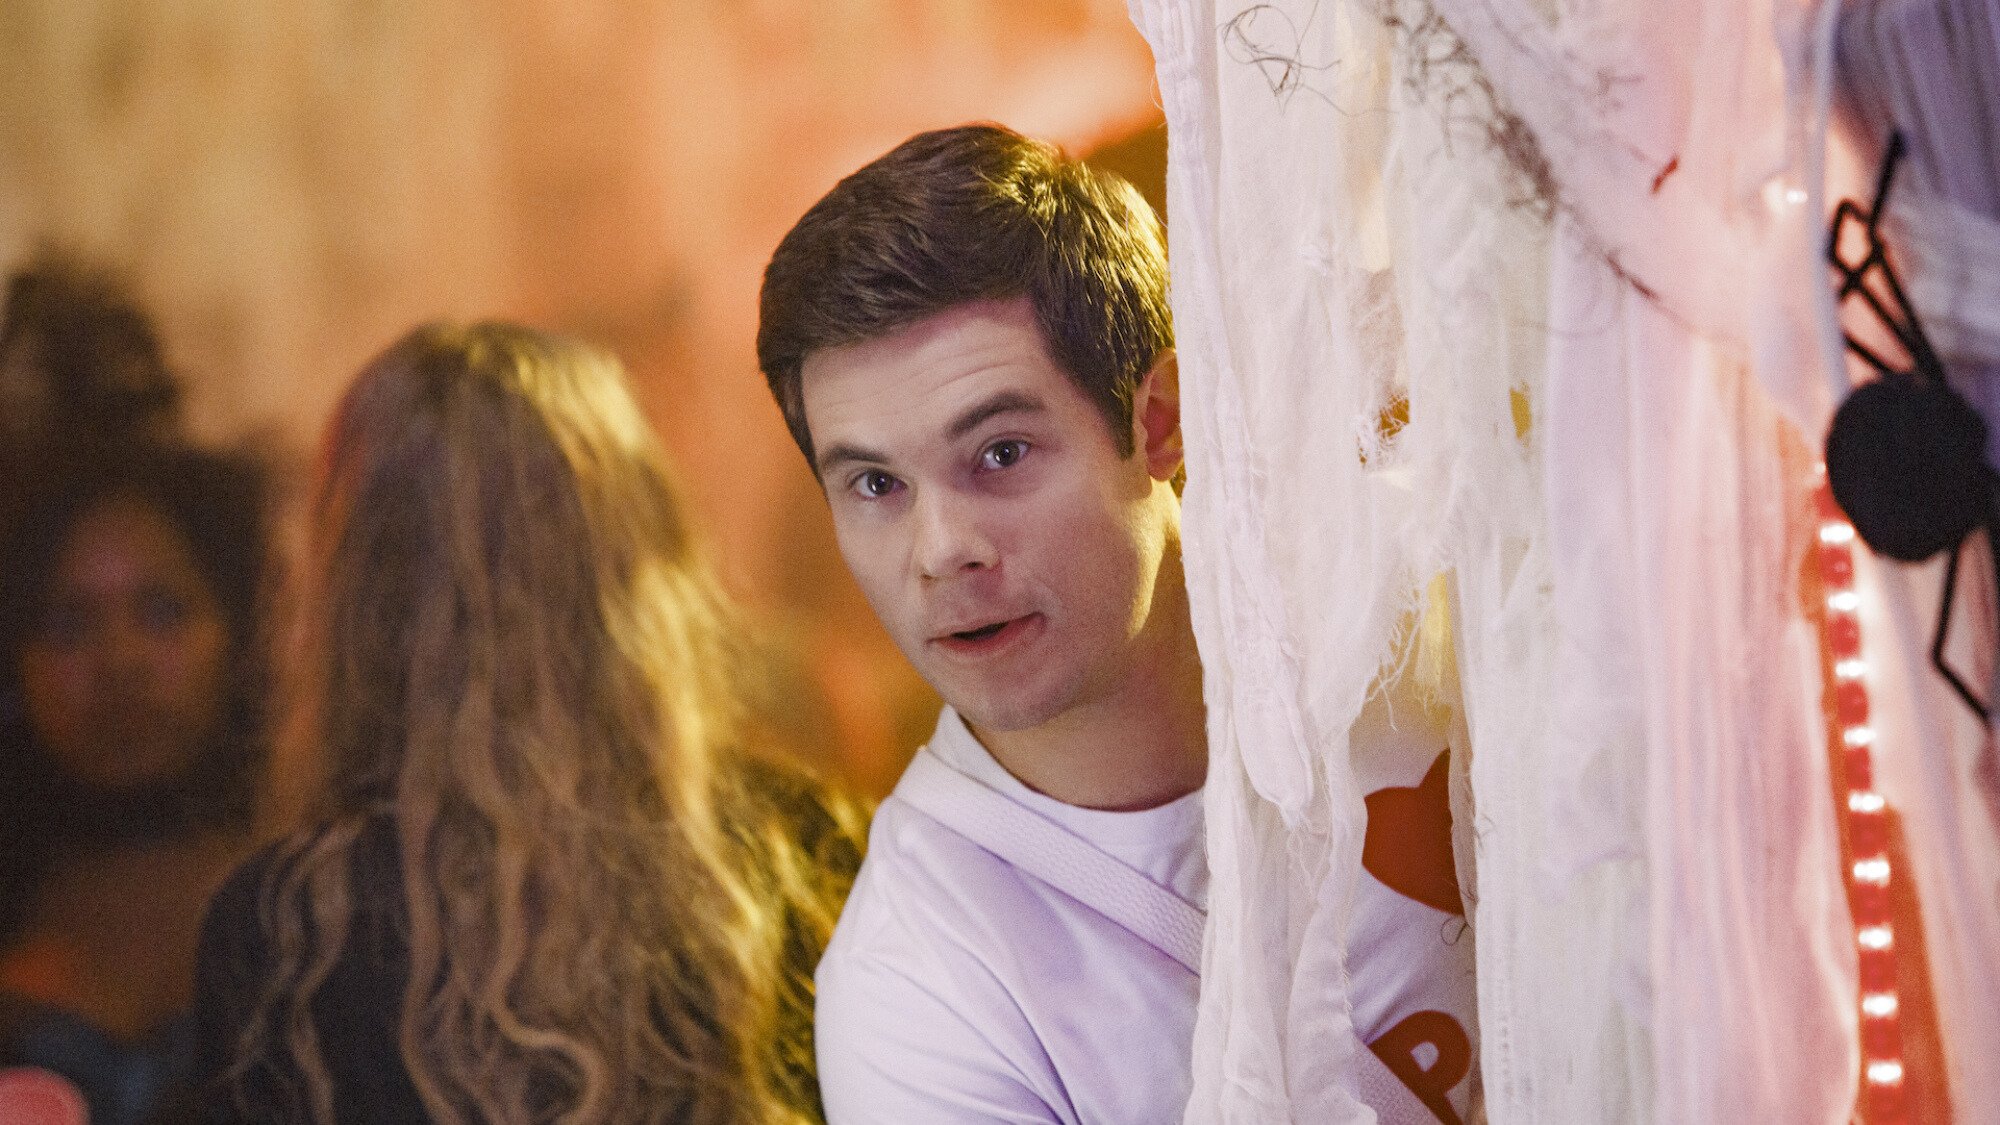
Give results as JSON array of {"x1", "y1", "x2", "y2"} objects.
[{"x1": 816, "y1": 709, "x2": 1208, "y2": 1125}]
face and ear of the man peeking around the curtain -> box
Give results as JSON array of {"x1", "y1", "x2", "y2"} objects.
[{"x1": 804, "y1": 298, "x2": 1178, "y2": 731}]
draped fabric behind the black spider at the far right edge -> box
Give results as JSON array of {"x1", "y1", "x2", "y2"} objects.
[{"x1": 1838, "y1": 0, "x2": 2000, "y2": 1121}]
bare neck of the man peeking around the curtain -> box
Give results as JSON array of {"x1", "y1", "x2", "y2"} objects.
[{"x1": 968, "y1": 567, "x2": 1208, "y2": 813}]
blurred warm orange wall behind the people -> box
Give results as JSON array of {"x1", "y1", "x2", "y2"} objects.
[{"x1": 0, "y1": 0, "x2": 1156, "y2": 789}]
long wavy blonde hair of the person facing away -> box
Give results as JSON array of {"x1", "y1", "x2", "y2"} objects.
[{"x1": 240, "y1": 322, "x2": 860, "y2": 1123}]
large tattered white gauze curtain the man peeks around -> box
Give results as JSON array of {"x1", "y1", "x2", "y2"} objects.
[{"x1": 1132, "y1": 0, "x2": 1858, "y2": 1123}]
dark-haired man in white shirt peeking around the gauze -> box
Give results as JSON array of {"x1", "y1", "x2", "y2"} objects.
[{"x1": 758, "y1": 126, "x2": 1480, "y2": 1125}]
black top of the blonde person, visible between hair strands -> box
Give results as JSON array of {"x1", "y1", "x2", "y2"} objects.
[{"x1": 194, "y1": 819, "x2": 428, "y2": 1125}]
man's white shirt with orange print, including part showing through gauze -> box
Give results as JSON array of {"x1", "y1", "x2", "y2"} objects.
[{"x1": 816, "y1": 701, "x2": 1480, "y2": 1125}]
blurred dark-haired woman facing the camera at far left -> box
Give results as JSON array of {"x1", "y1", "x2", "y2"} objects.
[{"x1": 0, "y1": 434, "x2": 266, "y2": 1125}]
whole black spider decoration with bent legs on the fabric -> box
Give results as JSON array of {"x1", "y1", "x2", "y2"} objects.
[{"x1": 1826, "y1": 132, "x2": 2000, "y2": 719}]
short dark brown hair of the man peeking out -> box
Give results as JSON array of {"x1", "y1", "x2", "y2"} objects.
[{"x1": 756, "y1": 124, "x2": 1174, "y2": 472}]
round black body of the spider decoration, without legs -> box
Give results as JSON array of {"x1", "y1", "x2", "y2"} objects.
[{"x1": 1826, "y1": 374, "x2": 1994, "y2": 563}]
